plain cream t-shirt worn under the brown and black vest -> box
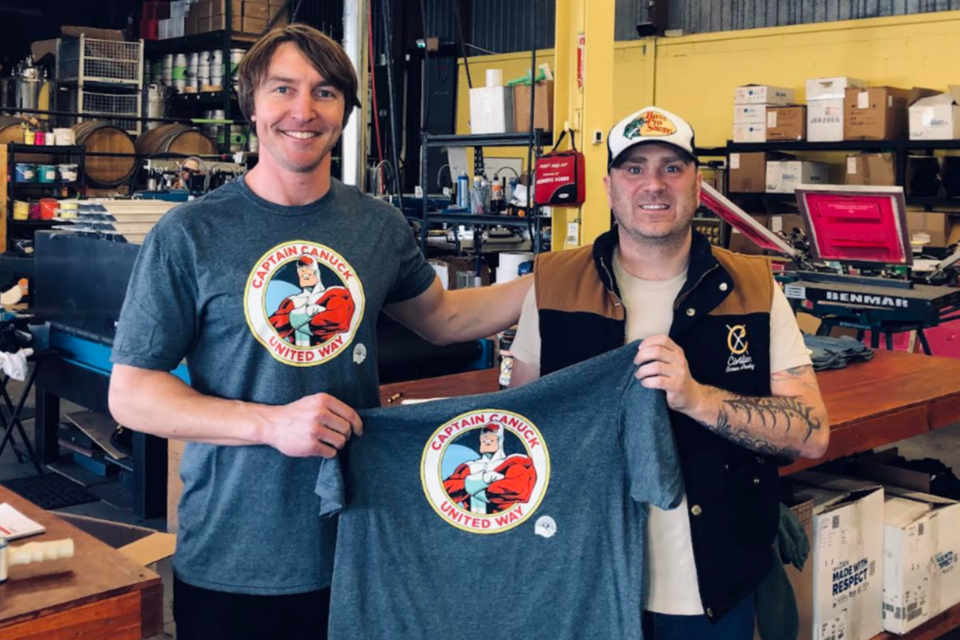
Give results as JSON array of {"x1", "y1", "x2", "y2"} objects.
[{"x1": 511, "y1": 253, "x2": 811, "y2": 615}]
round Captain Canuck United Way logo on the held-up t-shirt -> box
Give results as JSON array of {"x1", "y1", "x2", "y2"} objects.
[{"x1": 420, "y1": 409, "x2": 550, "y2": 534}]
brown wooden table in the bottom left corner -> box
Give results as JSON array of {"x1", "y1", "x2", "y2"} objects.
[{"x1": 0, "y1": 487, "x2": 163, "y2": 640}]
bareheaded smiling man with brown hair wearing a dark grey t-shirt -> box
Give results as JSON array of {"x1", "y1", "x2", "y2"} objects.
[{"x1": 110, "y1": 25, "x2": 530, "y2": 640}]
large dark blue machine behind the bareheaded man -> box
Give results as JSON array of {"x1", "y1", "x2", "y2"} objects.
[{"x1": 23, "y1": 200, "x2": 493, "y2": 518}]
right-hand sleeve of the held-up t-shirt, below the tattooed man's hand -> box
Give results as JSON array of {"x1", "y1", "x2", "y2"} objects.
[{"x1": 620, "y1": 380, "x2": 683, "y2": 509}]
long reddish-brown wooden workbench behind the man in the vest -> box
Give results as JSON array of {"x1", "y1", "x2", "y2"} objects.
[{"x1": 380, "y1": 351, "x2": 960, "y2": 640}]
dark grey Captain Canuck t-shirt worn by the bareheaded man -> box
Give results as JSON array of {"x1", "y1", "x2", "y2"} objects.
[{"x1": 112, "y1": 178, "x2": 435, "y2": 594}]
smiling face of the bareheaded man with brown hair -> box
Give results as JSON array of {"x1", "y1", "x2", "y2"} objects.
[{"x1": 251, "y1": 42, "x2": 345, "y2": 174}]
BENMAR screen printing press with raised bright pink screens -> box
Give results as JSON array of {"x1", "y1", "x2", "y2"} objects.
[{"x1": 702, "y1": 185, "x2": 960, "y2": 355}]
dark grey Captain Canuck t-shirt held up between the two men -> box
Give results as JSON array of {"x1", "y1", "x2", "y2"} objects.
[{"x1": 316, "y1": 344, "x2": 682, "y2": 640}]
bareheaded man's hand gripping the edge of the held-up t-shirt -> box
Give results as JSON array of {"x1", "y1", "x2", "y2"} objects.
[{"x1": 265, "y1": 393, "x2": 363, "y2": 458}]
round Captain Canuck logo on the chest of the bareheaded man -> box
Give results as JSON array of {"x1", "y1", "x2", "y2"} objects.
[{"x1": 244, "y1": 240, "x2": 365, "y2": 367}]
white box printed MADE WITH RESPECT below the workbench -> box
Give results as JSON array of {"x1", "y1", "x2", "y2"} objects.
[{"x1": 791, "y1": 471, "x2": 884, "y2": 640}]
